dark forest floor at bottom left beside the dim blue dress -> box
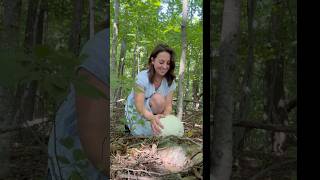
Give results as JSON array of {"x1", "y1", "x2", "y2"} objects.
[{"x1": 6, "y1": 120, "x2": 51, "y2": 180}]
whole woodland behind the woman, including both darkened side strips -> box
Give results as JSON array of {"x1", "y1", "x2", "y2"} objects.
[{"x1": 0, "y1": 0, "x2": 297, "y2": 180}]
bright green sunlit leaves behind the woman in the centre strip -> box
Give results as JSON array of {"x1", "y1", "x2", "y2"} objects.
[{"x1": 110, "y1": 0, "x2": 203, "y2": 104}]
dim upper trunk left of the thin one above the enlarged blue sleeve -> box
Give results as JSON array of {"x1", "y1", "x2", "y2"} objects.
[{"x1": 69, "y1": 0, "x2": 84, "y2": 55}]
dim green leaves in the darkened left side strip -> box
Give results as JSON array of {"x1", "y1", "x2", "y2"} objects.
[{"x1": 0, "y1": 46, "x2": 83, "y2": 108}]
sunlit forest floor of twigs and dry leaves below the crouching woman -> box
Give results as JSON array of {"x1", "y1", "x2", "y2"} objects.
[{"x1": 111, "y1": 103, "x2": 203, "y2": 179}]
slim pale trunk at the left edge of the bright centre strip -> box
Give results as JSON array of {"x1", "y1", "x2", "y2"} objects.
[{"x1": 111, "y1": 0, "x2": 120, "y2": 72}]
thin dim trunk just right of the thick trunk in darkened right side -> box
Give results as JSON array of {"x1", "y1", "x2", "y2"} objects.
[{"x1": 233, "y1": 0, "x2": 255, "y2": 154}]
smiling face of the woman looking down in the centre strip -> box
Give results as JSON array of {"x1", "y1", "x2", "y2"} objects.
[{"x1": 151, "y1": 51, "x2": 171, "y2": 76}]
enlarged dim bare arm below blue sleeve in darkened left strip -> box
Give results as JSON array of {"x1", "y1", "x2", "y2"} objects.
[{"x1": 76, "y1": 68, "x2": 110, "y2": 176}]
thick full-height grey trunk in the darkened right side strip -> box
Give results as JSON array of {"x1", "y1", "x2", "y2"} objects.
[{"x1": 211, "y1": 0, "x2": 241, "y2": 180}]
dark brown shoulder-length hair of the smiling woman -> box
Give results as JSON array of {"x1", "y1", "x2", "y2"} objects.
[{"x1": 148, "y1": 44, "x2": 176, "y2": 86}]
